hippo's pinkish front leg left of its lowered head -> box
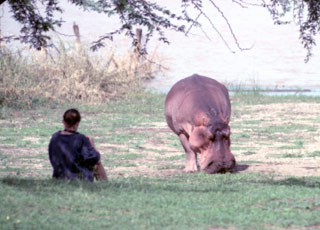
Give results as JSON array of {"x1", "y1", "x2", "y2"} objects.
[{"x1": 179, "y1": 134, "x2": 198, "y2": 173}]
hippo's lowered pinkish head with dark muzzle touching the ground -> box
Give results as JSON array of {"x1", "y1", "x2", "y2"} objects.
[{"x1": 189, "y1": 123, "x2": 236, "y2": 174}]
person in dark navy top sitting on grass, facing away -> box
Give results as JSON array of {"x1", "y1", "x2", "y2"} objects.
[{"x1": 49, "y1": 109, "x2": 108, "y2": 181}]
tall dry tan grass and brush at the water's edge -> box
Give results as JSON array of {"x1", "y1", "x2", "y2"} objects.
[{"x1": 0, "y1": 43, "x2": 161, "y2": 108}]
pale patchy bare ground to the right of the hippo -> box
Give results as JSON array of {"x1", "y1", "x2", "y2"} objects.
[{"x1": 231, "y1": 103, "x2": 320, "y2": 176}]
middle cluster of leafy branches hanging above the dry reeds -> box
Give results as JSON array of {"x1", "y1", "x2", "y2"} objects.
[{"x1": 90, "y1": 0, "x2": 191, "y2": 53}]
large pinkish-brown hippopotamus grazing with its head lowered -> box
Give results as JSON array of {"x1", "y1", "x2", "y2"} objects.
[{"x1": 165, "y1": 74, "x2": 236, "y2": 174}]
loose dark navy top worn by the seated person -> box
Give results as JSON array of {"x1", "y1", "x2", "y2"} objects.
[{"x1": 49, "y1": 131, "x2": 100, "y2": 181}]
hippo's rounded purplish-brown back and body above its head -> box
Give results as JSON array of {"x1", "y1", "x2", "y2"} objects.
[{"x1": 165, "y1": 74, "x2": 231, "y2": 133}]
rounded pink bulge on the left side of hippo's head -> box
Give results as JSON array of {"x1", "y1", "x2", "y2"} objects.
[{"x1": 189, "y1": 126, "x2": 213, "y2": 149}]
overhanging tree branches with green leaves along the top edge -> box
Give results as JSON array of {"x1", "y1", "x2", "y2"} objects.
[{"x1": 0, "y1": 0, "x2": 320, "y2": 61}]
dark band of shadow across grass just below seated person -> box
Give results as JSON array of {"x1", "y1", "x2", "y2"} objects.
[{"x1": 0, "y1": 173, "x2": 320, "y2": 194}]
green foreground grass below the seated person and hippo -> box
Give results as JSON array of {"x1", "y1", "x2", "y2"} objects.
[{"x1": 0, "y1": 173, "x2": 320, "y2": 229}]
